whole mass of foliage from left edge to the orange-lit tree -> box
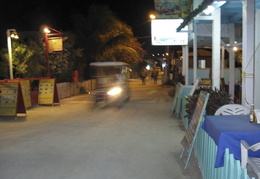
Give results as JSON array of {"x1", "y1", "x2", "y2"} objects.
[{"x1": 0, "y1": 5, "x2": 146, "y2": 82}]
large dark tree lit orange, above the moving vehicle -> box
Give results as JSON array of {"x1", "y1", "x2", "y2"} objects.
[{"x1": 73, "y1": 5, "x2": 145, "y2": 64}]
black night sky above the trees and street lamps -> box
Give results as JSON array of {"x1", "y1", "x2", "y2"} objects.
[{"x1": 0, "y1": 0, "x2": 168, "y2": 52}]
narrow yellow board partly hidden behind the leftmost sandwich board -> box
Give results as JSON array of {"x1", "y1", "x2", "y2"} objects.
[{"x1": 20, "y1": 80, "x2": 32, "y2": 108}]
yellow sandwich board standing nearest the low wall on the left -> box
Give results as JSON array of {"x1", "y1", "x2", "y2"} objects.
[{"x1": 38, "y1": 79, "x2": 59, "y2": 105}]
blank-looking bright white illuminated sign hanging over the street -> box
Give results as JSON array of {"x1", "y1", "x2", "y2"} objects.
[{"x1": 151, "y1": 19, "x2": 188, "y2": 46}]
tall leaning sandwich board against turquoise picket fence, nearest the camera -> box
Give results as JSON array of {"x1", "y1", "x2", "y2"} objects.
[{"x1": 180, "y1": 91, "x2": 209, "y2": 169}]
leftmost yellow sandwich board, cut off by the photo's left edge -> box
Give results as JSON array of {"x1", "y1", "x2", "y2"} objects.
[{"x1": 0, "y1": 82, "x2": 26, "y2": 117}]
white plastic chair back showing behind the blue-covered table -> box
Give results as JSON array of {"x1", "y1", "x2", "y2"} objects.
[{"x1": 215, "y1": 104, "x2": 250, "y2": 115}]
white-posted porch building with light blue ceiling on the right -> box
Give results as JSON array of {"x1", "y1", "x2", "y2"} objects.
[{"x1": 178, "y1": 0, "x2": 260, "y2": 109}]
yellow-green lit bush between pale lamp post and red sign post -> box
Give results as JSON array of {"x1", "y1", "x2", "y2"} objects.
[{"x1": 0, "y1": 32, "x2": 46, "y2": 79}]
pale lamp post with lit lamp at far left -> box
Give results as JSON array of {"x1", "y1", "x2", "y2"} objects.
[{"x1": 6, "y1": 29, "x2": 19, "y2": 79}]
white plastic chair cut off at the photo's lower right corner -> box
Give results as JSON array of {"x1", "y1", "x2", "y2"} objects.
[{"x1": 241, "y1": 140, "x2": 260, "y2": 179}]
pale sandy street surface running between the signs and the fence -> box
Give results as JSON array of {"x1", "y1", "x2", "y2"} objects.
[{"x1": 0, "y1": 80, "x2": 201, "y2": 179}]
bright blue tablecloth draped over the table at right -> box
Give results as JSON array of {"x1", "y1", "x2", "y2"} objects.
[{"x1": 202, "y1": 115, "x2": 260, "y2": 168}]
